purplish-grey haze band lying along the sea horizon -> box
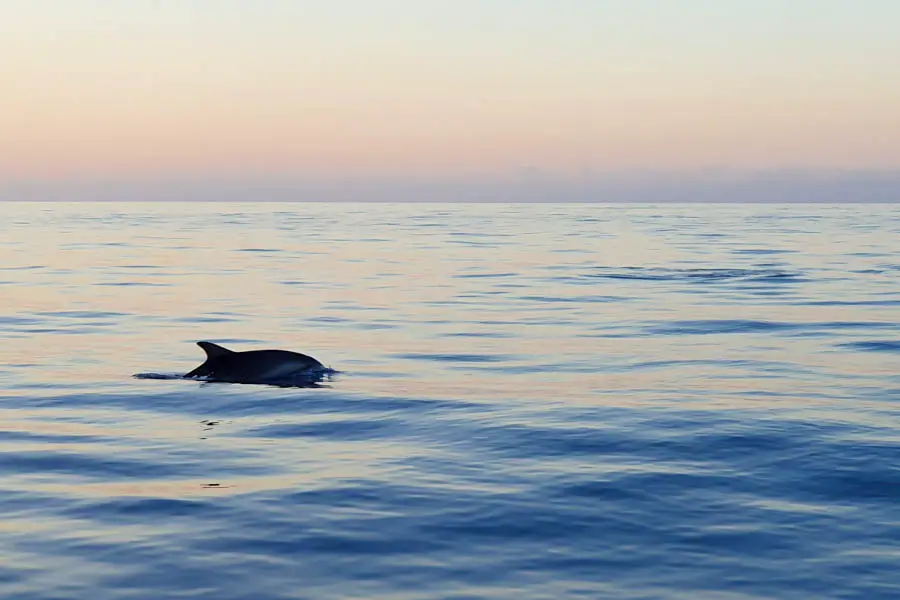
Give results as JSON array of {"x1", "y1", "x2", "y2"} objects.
[{"x1": 7, "y1": 171, "x2": 900, "y2": 203}]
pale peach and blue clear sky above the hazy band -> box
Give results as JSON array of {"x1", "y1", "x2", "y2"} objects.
[{"x1": 0, "y1": 0, "x2": 900, "y2": 180}]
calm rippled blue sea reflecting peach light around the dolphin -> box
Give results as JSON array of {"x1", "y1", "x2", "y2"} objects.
[{"x1": 0, "y1": 203, "x2": 900, "y2": 600}]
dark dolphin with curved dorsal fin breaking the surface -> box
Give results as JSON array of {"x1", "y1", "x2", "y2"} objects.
[{"x1": 184, "y1": 342, "x2": 333, "y2": 384}]
